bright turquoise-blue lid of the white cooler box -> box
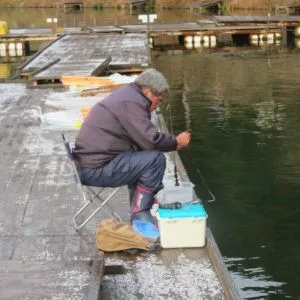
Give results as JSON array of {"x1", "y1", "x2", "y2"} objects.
[{"x1": 158, "y1": 204, "x2": 207, "y2": 219}]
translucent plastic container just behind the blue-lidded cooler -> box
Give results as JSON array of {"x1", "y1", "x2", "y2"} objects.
[{"x1": 160, "y1": 181, "x2": 194, "y2": 204}]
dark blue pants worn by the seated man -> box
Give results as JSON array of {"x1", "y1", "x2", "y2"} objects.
[{"x1": 79, "y1": 150, "x2": 166, "y2": 193}]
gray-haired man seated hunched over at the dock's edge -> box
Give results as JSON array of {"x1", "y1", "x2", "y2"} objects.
[{"x1": 75, "y1": 69, "x2": 190, "y2": 224}]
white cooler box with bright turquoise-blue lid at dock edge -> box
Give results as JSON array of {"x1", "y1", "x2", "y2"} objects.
[{"x1": 157, "y1": 204, "x2": 207, "y2": 248}]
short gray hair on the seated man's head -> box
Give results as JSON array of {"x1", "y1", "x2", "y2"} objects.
[{"x1": 134, "y1": 69, "x2": 169, "y2": 96}]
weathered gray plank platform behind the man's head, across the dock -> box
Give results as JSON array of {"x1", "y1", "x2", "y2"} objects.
[{"x1": 20, "y1": 33, "x2": 147, "y2": 79}]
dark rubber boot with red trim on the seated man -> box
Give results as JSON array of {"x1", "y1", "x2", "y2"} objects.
[{"x1": 130, "y1": 185, "x2": 157, "y2": 227}]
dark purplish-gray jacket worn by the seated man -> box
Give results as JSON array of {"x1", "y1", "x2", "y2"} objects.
[{"x1": 75, "y1": 83, "x2": 177, "y2": 168}]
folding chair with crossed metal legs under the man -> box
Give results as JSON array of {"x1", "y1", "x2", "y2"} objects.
[{"x1": 61, "y1": 132, "x2": 122, "y2": 230}]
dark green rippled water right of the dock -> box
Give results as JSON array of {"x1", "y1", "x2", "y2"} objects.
[{"x1": 155, "y1": 50, "x2": 300, "y2": 299}]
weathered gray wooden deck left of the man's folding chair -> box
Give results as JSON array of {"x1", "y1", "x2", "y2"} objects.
[{"x1": 0, "y1": 84, "x2": 109, "y2": 300}]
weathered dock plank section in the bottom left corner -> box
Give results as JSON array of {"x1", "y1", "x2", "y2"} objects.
[{"x1": 0, "y1": 261, "x2": 91, "y2": 300}]
